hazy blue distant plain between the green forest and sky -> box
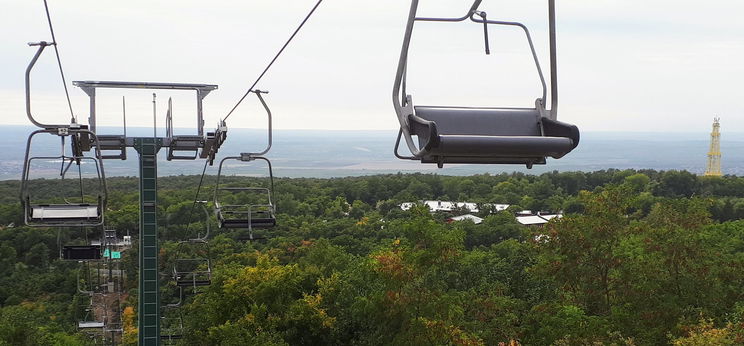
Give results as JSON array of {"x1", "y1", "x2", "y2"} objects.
[{"x1": 0, "y1": 126, "x2": 744, "y2": 180}]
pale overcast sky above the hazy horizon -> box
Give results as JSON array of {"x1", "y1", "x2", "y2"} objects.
[{"x1": 0, "y1": 0, "x2": 744, "y2": 133}]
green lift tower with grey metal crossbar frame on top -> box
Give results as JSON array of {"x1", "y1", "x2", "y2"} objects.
[{"x1": 73, "y1": 81, "x2": 226, "y2": 346}]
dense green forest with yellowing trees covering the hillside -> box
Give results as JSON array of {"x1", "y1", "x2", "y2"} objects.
[{"x1": 0, "y1": 170, "x2": 744, "y2": 345}]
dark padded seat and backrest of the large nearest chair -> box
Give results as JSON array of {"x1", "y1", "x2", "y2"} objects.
[{"x1": 410, "y1": 106, "x2": 579, "y2": 165}]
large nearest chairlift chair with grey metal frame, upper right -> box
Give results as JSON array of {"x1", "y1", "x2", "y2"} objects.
[{"x1": 392, "y1": 0, "x2": 579, "y2": 168}]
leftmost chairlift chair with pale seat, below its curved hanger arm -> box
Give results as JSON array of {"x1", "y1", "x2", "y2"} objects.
[{"x1": 21, "y1": 127, "x2": 106, "y2": 227}]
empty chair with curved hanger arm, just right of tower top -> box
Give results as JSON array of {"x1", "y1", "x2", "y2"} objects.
[{"x1": 214, "y1": 90, "x2": 276, "y2": 240}]
